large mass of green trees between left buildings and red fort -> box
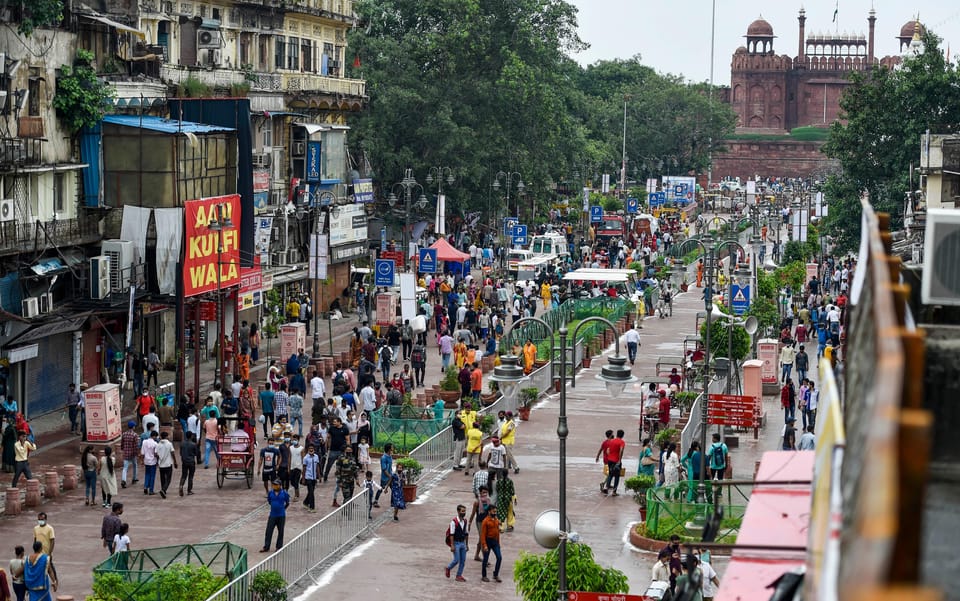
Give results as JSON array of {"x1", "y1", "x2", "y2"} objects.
[{"x1": 349, "y1": 0, "x2": 734, "y2": 230}]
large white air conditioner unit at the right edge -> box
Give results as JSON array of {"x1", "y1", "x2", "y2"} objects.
[{"x1": 920, "y1": 209, "x2": 960, "y2": 305}]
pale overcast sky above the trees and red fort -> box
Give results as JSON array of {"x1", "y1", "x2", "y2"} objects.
[{"x1": 568, "y1": 0, "x2": 960, "y2": 85}]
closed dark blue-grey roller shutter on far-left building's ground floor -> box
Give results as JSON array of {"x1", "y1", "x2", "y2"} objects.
[{"x1": 24, "y1": 333, "x2": 73, "y2": 418}]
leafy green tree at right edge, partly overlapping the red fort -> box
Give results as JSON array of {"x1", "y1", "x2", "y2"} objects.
[{"x1": 823, "y1": 30, "x2": 960, "y2": 251}]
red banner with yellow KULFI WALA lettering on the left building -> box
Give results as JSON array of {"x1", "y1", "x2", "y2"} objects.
[{"x1": 183, "y1": 194, "x2": 240, "y2": 298}]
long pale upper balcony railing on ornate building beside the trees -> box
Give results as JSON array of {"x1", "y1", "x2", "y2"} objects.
[{"x1": 160, "y1": 65, "x2": 367, "y2": 98}]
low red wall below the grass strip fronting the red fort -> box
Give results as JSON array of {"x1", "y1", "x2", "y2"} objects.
[{"x1": 713, "y1": 140, "x2": 835, "y2": 181}]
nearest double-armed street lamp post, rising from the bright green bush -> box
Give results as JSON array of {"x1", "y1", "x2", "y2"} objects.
[{"x1": 492, "y1": 315, "x2": 637, "y2": 601}]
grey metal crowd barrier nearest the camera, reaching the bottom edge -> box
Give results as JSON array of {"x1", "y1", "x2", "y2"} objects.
[{"x1": 207, "y1": 490, "x2": 372, "y2": 601}]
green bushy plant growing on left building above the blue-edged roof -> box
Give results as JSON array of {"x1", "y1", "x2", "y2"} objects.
[{"x1": 53, "y1": 50, "x2": 113, "y2": 133}]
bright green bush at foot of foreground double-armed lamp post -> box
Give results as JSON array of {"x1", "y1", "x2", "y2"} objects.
[{"x1": 513, "y1": 543, "x2": 630, "y2": 601}]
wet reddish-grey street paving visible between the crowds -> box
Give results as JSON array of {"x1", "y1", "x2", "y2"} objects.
[{"x1": 0, "y1": 266, "x2": 796, "y2": 601}]
